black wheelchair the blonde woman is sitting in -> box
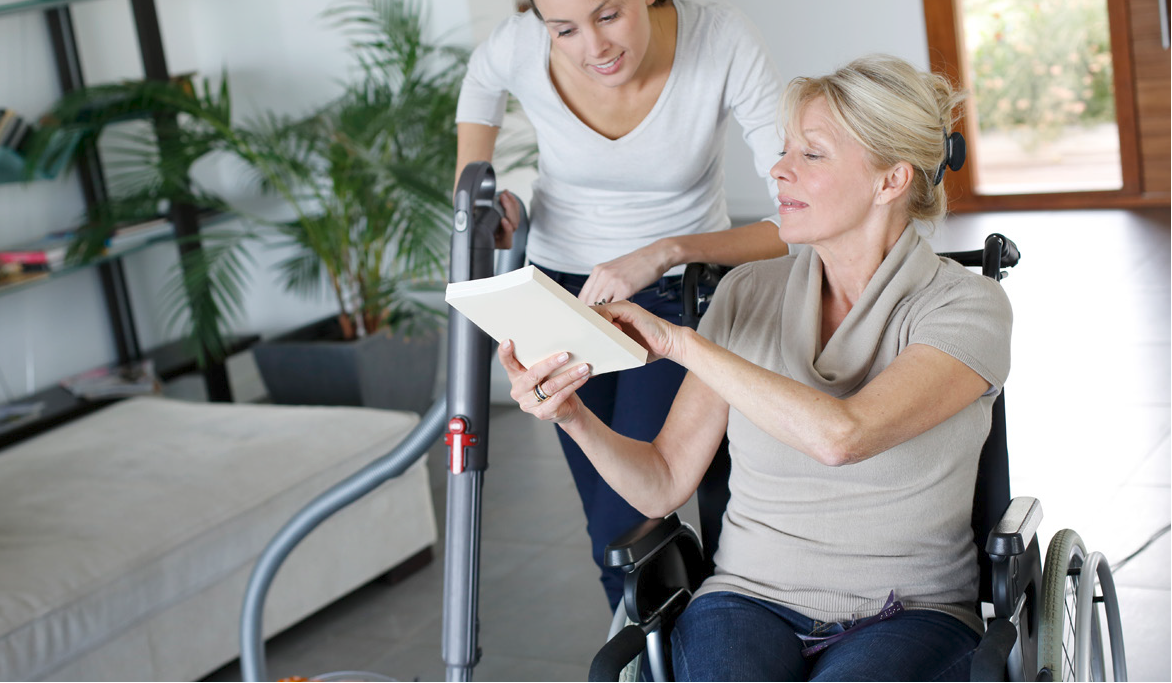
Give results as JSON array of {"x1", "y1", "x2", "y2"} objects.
[{"x1": 590, "y1": 234, "x2": 1127, "y2": 681}]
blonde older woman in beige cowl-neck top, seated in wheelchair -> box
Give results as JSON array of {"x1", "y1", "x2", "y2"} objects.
[{"x1": 500, "y1": 56, "x2": 1011, "y2": 681}]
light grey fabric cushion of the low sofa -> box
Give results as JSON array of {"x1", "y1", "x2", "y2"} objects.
[{"x1": 0, "y1": 398, "x2": 434, "y2": 679}]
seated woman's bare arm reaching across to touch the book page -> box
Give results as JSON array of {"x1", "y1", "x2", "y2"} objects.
[{"x1": 600, "y1": 302, "x2": 989, "y2": 466}]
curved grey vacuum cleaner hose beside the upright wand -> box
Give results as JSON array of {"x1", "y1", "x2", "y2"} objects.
[{"x1": 240, "y1": 396, "x2": 448, "y2": 681}]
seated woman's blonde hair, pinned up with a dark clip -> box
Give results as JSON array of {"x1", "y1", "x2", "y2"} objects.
[{"x1": 781, "y1": 55, "x2": 965, "y2": 224}]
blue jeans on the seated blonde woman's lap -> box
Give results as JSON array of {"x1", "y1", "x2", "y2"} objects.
[{"x1": 672, "y1": 592, "x2": 979, "y2": 681}]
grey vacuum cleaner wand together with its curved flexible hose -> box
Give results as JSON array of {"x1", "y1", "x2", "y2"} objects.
[{"x1": 240, "y1": 162, "x2": 527, "y2": 681}]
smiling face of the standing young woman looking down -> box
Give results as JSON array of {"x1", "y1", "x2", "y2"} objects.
[{"x1": 536, "y1": 0, "x2": 653, "y2": 87}]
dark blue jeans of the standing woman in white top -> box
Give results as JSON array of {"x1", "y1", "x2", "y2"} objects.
[{"x1": 538, "y1": 266, "x2": 711, "y2": 612}]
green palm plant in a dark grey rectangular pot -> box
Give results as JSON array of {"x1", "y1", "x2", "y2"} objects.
[{"x1": 238, "y1": 1, "x2": 466, "y2": 411}]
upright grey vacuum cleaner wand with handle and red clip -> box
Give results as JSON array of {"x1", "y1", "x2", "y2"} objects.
[{"x1": 443, "y1": 162, "x2": 527, "y2": 681}]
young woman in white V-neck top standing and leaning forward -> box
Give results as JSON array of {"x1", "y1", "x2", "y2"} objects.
[{"x1": 457, "y1": 0, "x2": 786, "y2": 607}]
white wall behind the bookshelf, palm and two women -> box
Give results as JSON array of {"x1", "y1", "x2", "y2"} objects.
[{"x1": 0, "y1": 0, "x2": 927, "y2": 401}]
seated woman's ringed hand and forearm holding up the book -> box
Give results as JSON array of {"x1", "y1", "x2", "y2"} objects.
[{"x1": 497, "y1": 341, "x2": 728, "y2": 517}]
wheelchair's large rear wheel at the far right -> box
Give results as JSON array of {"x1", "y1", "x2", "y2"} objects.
[{"x1": 1037, "y1": 528, "x2": 1127, "y2": 681}]
